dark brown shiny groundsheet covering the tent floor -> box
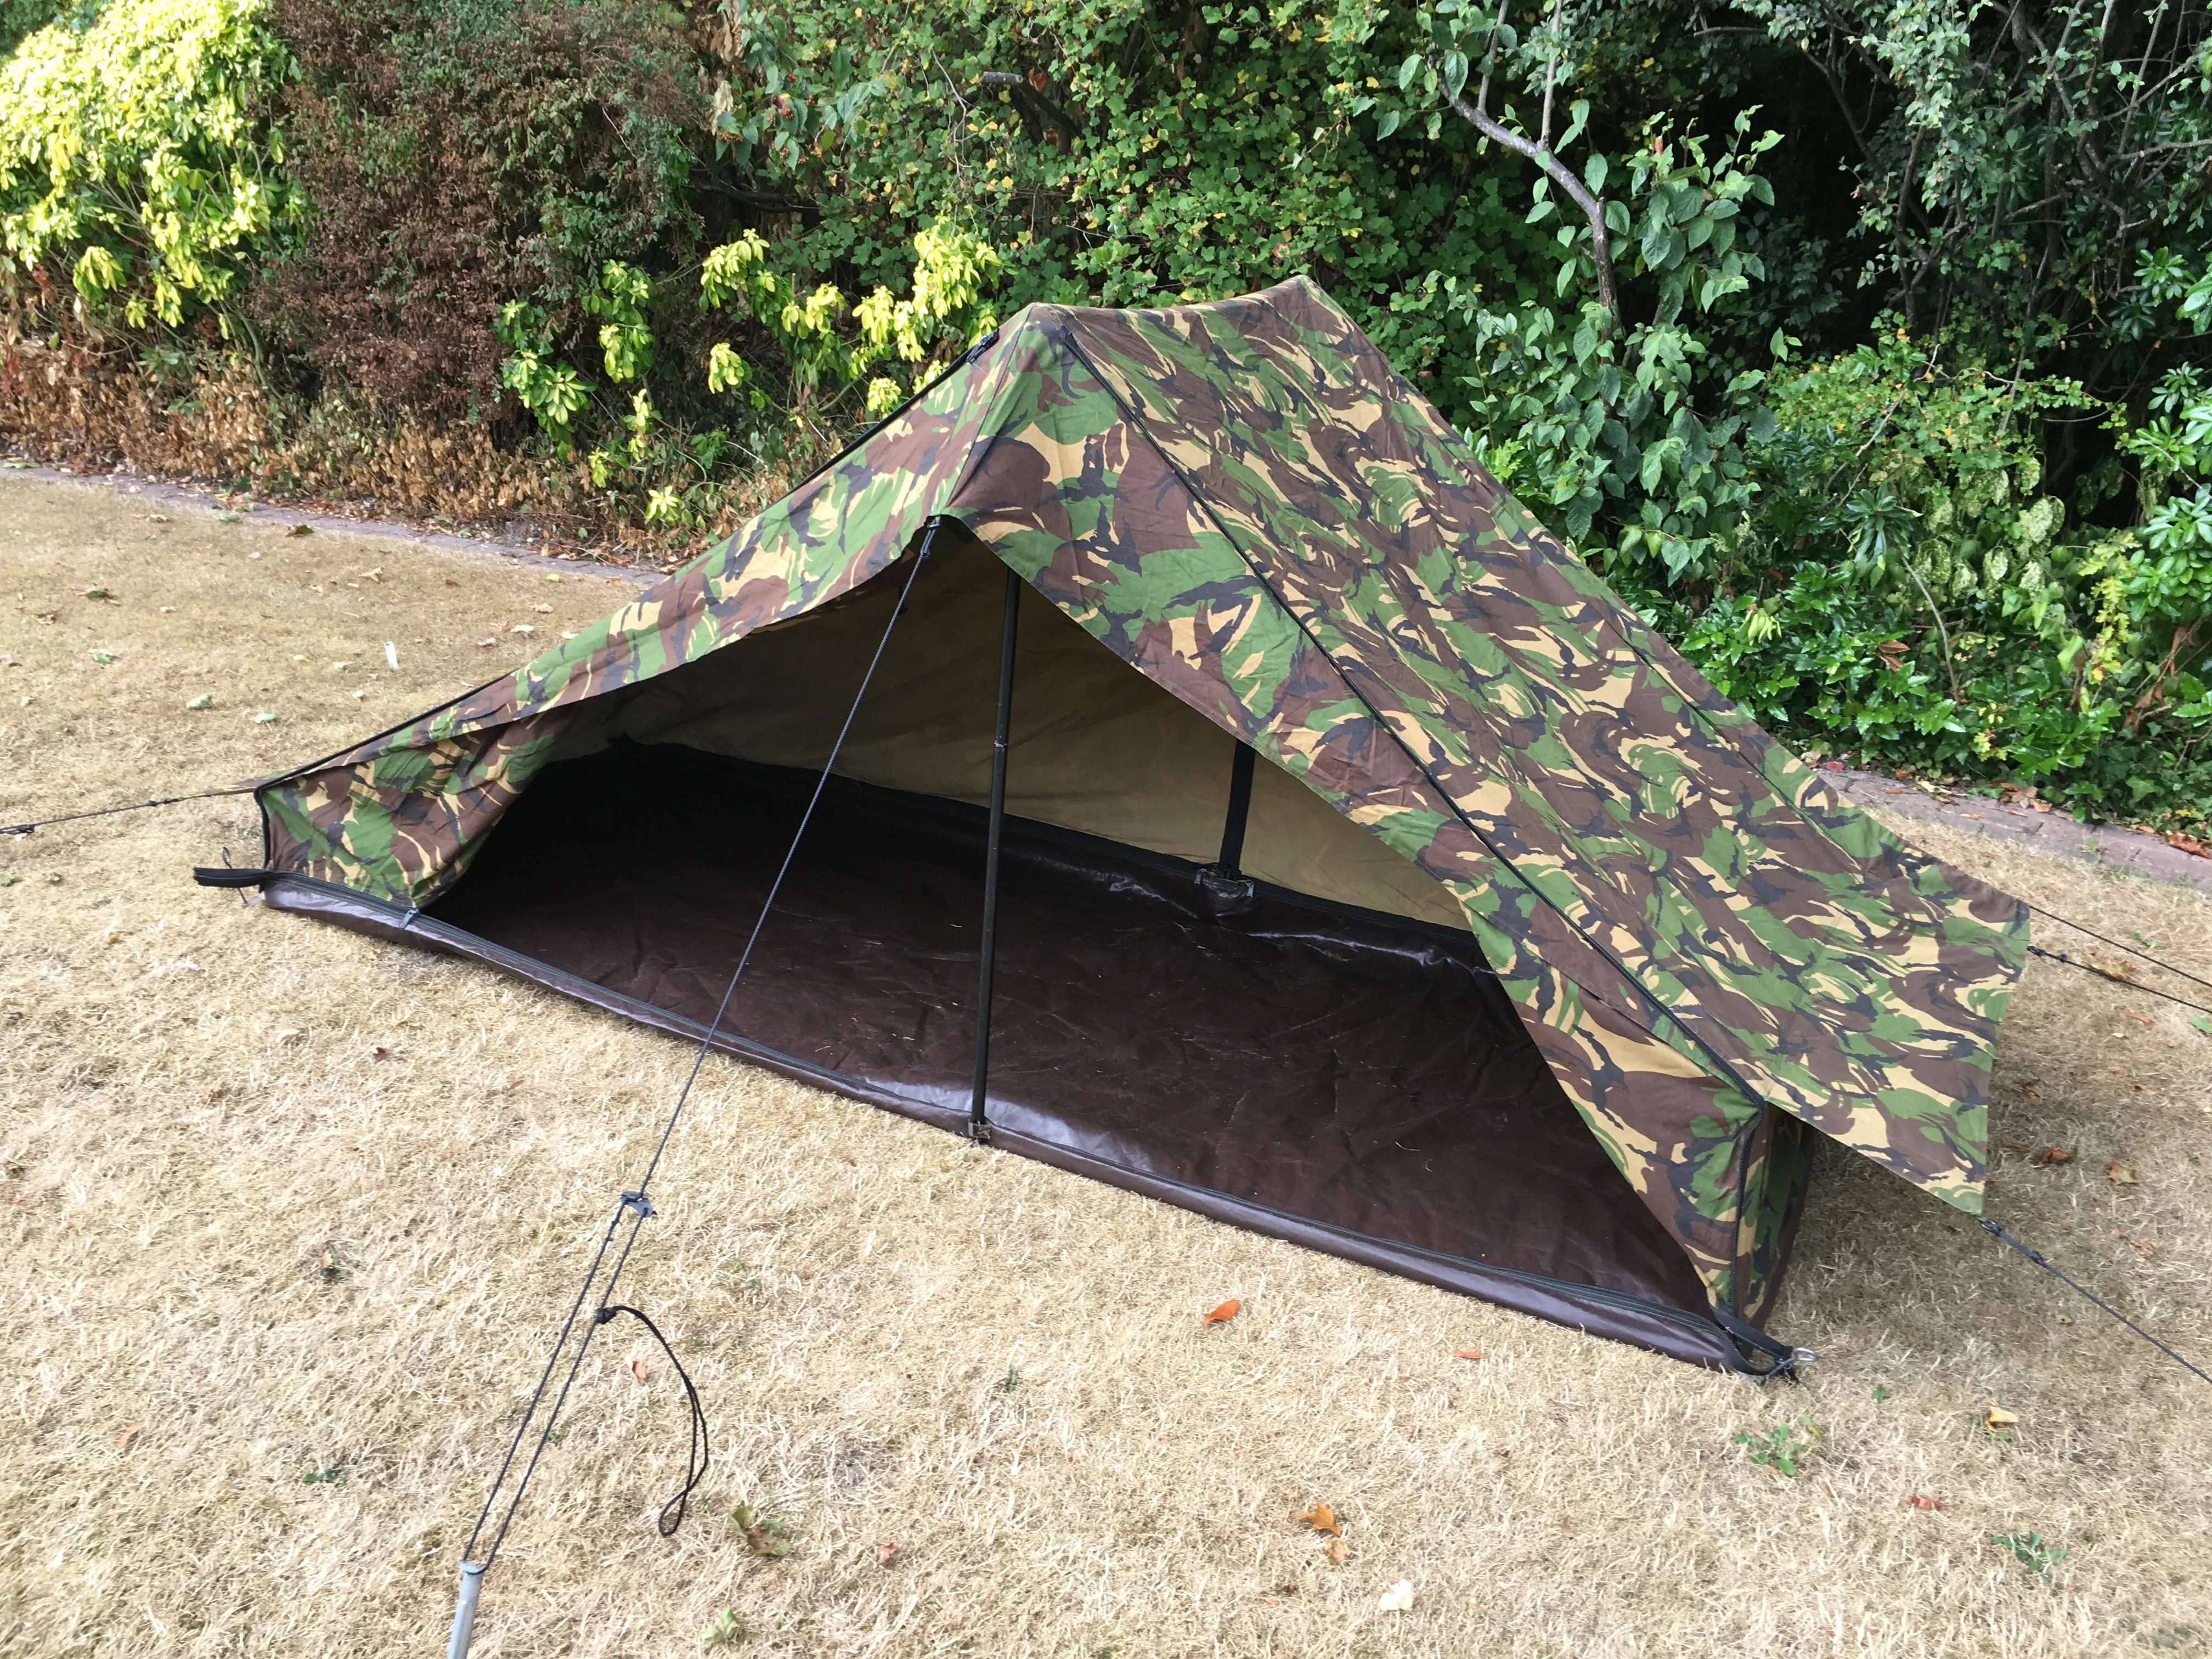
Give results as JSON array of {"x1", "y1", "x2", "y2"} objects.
[{"x1": 431, "y1": 746, "x2": 1712, "y2": 1327}]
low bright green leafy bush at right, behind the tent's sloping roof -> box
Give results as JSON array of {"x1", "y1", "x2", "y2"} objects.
[{"x1": 1633, "y1": 309, "x2": 2212, "y2": 825}]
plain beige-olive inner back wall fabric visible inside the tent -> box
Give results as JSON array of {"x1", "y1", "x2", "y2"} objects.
[{"x1": 539, "y1": 535, "x2": 1466, "y2": 927}]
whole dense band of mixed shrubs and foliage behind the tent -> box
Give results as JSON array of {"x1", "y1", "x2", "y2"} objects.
[{"x1": 0, "y1": 0, "x2": 2212, "y2": 827}]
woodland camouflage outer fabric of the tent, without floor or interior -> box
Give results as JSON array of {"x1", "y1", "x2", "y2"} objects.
[{"x1": 261, "y1": 279, "x2": 2028, "y2": 1307}]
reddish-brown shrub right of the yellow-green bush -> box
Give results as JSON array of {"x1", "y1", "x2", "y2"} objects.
[{"x1": 257, "y1": 0, "x2": 703, "y2": 420}]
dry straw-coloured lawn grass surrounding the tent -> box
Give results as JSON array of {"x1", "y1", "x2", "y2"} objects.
[{"x1": 0, "y1": 480, "x2": 2212, "y2": 1659}]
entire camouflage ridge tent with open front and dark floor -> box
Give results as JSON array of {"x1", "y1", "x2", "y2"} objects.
[{"x1": 238, "y1": 281, "x2": 2026, "y2": 1367}]
